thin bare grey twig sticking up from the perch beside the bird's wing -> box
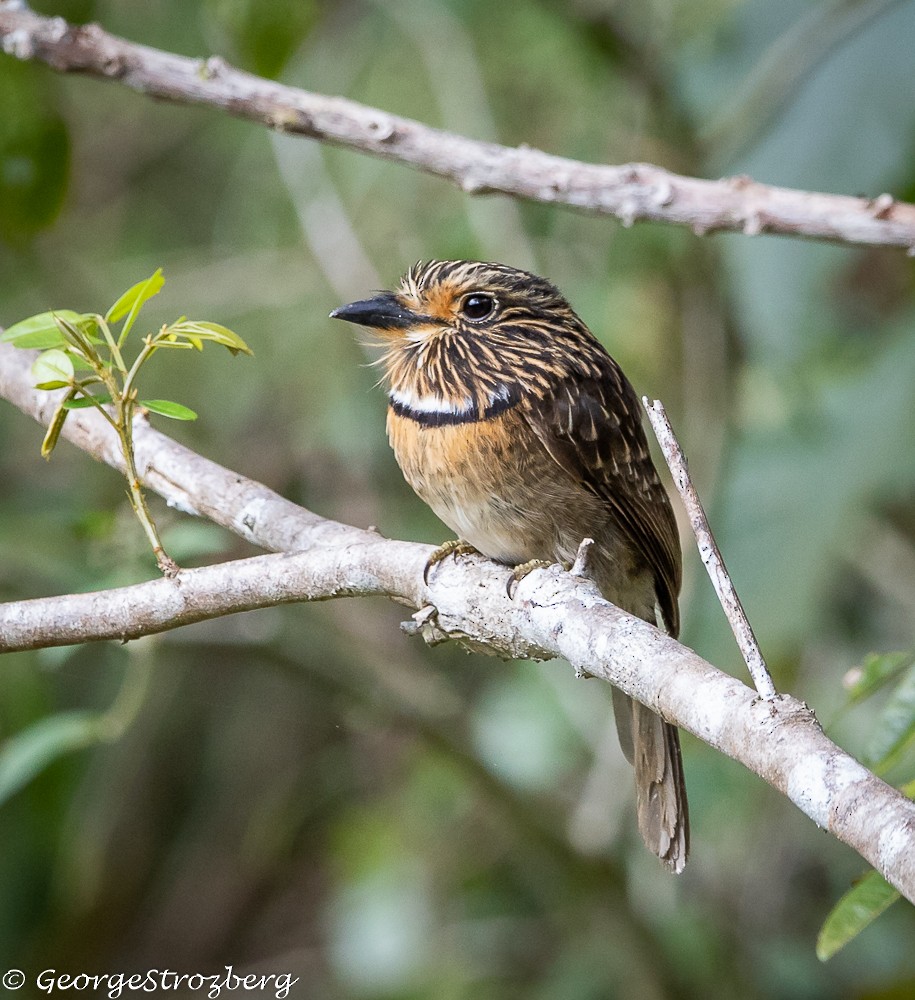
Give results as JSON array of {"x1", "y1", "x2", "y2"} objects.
[{"x1": 642, "y1": 396, "x2": 778, "y2": 698}]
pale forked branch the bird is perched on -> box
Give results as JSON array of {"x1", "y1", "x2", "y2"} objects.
[{"x1": 0, "y1": 344, "x2": 915, "y2": 901}]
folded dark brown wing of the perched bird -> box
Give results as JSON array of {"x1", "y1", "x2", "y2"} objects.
[{"x1": 525, "y1": 364, "x2": 681, "y2": 636}]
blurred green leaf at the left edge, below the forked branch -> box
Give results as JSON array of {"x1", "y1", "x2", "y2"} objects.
[{"x1": 0, "y1": 712, "x2": 100, "y2": 803}]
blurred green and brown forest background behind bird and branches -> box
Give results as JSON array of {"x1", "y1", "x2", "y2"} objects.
[{"x1": 0, "y1": 0, "x2": 915, "y2": 1000}]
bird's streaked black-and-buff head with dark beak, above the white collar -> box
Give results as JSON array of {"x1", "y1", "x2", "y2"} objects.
[{"x1": 331, "y1": 261, "x2": 597, "y2": 409}]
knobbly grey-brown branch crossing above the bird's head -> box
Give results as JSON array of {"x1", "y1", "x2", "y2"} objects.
[{"x1": 0, "y1": 0, "x2": 915, "y2": 252}]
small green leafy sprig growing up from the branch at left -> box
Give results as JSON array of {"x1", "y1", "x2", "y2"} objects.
[{"x1": 0, "y1": 268, "x2": 251, "y2": 573}]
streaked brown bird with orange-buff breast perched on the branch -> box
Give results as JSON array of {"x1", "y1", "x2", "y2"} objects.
[{"x1": 330, "y1": 260, "x2": 689, "y2": 872}]
